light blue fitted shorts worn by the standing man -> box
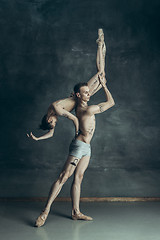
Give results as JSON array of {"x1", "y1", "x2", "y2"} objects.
[{"x1": 69, "y1": 139, "x2": 91, "y2": 159}]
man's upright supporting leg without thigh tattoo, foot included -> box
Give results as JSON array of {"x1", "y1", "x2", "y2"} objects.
[{"x1": 71, "y1": 156, "x2": 92, "y2": 221}]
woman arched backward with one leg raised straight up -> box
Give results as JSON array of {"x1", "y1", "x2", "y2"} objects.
[{"x1": 27, "y1": 29, "x2": 106, "y2": 141}]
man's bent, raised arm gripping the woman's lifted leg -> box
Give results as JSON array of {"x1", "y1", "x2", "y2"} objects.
[{"x1": 87, "y1": 75, "x2": 115, "y2": 115}]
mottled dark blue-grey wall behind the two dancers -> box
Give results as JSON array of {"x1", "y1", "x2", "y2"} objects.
[{"x1": 0, "y1": 0, "x2": 160, "y2": 197}]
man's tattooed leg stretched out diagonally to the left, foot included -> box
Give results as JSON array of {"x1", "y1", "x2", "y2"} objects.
[{"x1": 35, "y1": 156, "x2": 79, "y2": 227}]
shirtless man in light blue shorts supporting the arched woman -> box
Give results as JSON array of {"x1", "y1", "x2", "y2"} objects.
[{"x1": 35, "y1": 39, "x2": 114, "y2": 227}]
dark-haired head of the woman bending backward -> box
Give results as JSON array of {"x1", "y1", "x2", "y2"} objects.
[{"x1": 39, "y1": 114, "x2": 57, "y2": 130}]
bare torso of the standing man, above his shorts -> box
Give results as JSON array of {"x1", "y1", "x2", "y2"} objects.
[{"x1": 76, "y1": 106, "x2": 95, "y2": 143}]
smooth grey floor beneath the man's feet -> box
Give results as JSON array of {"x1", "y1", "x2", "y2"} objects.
[{"x1": 0, "y1": 202, "x2": 160, "y2": 240}]
